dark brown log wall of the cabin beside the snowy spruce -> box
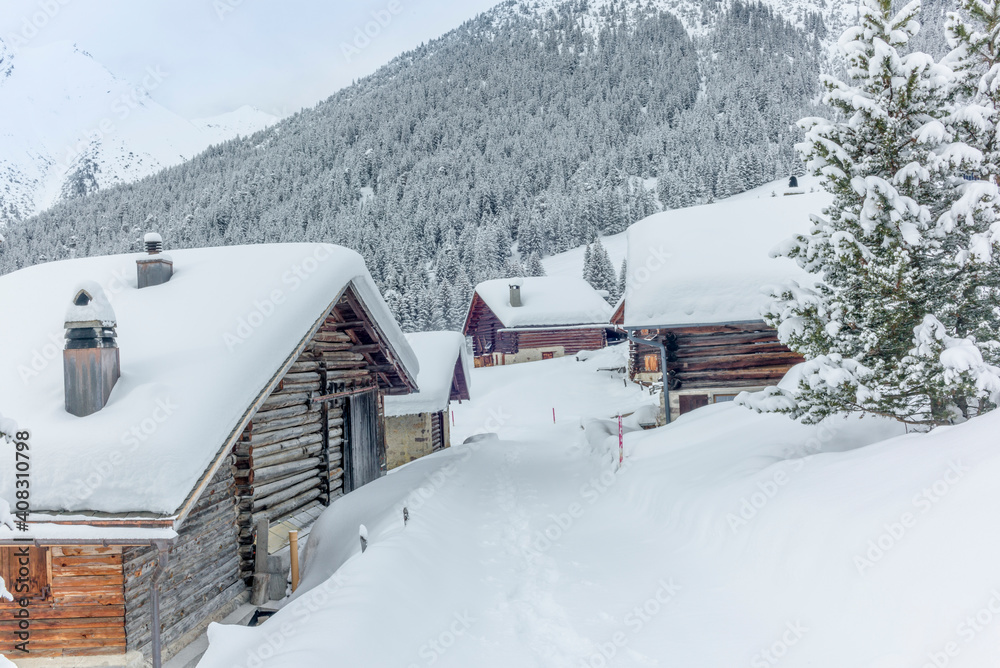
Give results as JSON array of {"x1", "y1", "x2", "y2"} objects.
[{"x1": 656, "y1": 322, "x2": 802, "y2": 389}]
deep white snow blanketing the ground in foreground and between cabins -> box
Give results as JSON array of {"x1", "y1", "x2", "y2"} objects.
[{"x1": 200, "y1": 344, "x2": 1000, "y2": 668}]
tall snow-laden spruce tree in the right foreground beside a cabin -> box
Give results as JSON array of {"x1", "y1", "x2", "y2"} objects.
[{"x1": 742, "y1": 0, "x2": 1000, "y2": 426}]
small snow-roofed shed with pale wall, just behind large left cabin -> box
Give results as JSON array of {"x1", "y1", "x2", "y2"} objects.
[{"x1": 385, "y1": 332, "x2": 472, "y2": 469}]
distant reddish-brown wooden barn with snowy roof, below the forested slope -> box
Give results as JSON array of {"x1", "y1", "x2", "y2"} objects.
[{"x1": 464, "y1": 276, "x2": 614, "y2": 367}]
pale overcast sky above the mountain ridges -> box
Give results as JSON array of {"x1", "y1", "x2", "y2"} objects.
[{"x1": 0, "y1": 0, "x2": 499, "y2": 118}]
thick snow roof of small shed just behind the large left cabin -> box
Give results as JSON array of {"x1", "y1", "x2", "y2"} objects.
[{"x1": 385, "y1": 332, "x2": 472, "y2": 417}]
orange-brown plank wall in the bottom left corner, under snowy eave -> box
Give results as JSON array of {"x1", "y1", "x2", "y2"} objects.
[{"x1": 0, "y1": 546, "x2": 126, "y2": 660}]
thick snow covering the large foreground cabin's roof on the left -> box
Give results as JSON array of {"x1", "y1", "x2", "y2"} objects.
[{"x1": 0, "y1": 244, "x2": 419, "y2": 515}]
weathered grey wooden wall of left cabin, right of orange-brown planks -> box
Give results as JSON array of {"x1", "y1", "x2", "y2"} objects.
[{"x1": 123, "y1": 457, "x2": 246, "y2": 660}]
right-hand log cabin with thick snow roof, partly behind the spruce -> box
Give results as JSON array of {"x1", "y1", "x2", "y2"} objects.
[{"x1": 613, "y1": 193, "x2": 829, "y2": 420}]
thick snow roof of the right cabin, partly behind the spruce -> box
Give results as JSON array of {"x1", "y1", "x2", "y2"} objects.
[{"x1": 625, "y1": 192, "x2": 832, "y2": 327}]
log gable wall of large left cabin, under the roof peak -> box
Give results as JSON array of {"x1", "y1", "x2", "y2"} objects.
[{"x1": 235, "y1": 290, "x2": 391, "y2": 584}]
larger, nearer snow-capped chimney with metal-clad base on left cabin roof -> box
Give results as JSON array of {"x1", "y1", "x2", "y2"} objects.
[{"x1": 63, "y1": 281, "x2": 121, "y2": 417}]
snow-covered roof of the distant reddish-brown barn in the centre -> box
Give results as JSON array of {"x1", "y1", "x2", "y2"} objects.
[{"x1": 476, "y1": 276, "x2": 611, "y2": 327}]
